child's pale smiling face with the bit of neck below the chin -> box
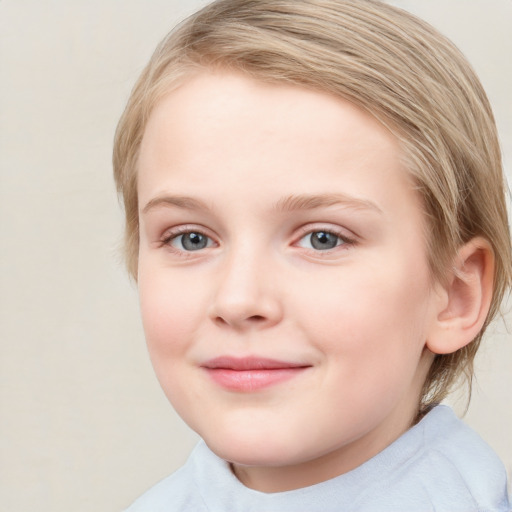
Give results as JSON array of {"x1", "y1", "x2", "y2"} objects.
[{"x1": 138, "y1": 72, "x2": 439, "y2": 490}]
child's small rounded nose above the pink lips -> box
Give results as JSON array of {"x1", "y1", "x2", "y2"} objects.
[{"x1": 210, "y1": 246, "x2": 283, "y2": 331}]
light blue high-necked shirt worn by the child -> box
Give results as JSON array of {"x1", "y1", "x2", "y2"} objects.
[{"x1": 126, "y1": 405, "x2": 509, "y2": 512}]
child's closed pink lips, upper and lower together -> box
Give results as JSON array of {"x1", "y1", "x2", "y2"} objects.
[{"x1": 202, "y1": 356, "x2": 310, "y2": 392}]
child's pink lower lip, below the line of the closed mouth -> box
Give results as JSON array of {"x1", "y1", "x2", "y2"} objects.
[{"x1": 206, "y1": 367, "x2": 307, "y2": 392}]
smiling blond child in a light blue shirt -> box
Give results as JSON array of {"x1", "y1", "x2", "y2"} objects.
[{"x1": 114, "y1": 0, "x2": 512, "y2": 512}]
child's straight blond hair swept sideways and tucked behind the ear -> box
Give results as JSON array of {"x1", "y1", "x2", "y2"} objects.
[{"x1": 113, "y1": 0, "x2": 512, "y2": 409}]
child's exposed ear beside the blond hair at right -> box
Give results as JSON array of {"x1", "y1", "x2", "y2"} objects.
[{"x1": 427, "y1": 237, "x2": 494, "y2": 354}]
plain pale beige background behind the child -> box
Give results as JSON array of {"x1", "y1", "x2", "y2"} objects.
[{"x1": 0, "y1": 0, "x2": 512, "y2": 512}]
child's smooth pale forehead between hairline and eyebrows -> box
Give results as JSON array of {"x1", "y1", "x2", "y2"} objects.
[{"x1": 138, "y1": 71, "x2": 418, "y2": 220}]
